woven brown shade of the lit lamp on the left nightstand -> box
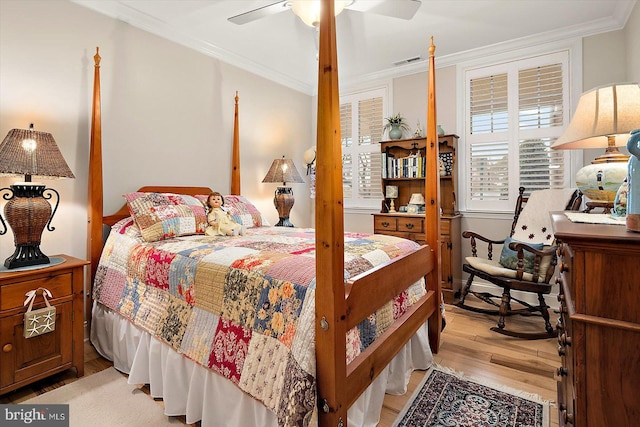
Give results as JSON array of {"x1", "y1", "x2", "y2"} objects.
[{"x1": 0, "y1": 125, "x2": 75, "y2": 181}]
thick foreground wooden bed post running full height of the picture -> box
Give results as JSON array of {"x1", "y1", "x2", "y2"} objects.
[{"x1": 315, "y1": 0, "x2": 348, "y2": 427}]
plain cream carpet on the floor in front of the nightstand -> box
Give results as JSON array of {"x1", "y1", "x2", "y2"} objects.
[{"x1": 20, "y1": 367, "x2": 182, "y2": 427}]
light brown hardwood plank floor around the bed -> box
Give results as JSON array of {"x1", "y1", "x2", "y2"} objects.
[{"x1": 0, "y1": 305, "x2": 560, "y2": 427}]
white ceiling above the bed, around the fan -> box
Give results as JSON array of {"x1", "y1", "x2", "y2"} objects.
[{"x1": 72, "y1": 0, "x2": 636, "y2": 94}]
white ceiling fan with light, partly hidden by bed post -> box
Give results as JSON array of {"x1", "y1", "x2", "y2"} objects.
[{"x1": 228, "y1": 0, "x2": 422, "y2": 27}]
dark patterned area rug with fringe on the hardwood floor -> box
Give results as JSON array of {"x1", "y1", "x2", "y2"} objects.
[{"x1": 393, "y1": 367, "x2": 549, "y2": 427}]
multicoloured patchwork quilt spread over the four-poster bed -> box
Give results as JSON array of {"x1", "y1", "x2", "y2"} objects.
[{"x1": 93, "y1": 218, "x2": 425, "y2": 426}]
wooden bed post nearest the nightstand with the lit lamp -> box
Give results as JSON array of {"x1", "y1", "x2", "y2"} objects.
[{"x1": 85, "y1": 47, "x2": 103, "y2": 325}]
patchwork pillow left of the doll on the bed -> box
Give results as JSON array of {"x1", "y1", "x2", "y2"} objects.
[{"x1": 124, "y1": 192, "x2": 207, "y2": 242}]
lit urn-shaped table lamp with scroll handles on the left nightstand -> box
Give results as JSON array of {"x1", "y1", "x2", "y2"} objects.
[{"x1": 0, "y1": 124, "x2": 75, "y2": 269}]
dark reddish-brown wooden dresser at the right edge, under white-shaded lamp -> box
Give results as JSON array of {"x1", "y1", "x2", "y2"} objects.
[{"x1": 552, "y1": 213, "x2": 640, "y2": 427}]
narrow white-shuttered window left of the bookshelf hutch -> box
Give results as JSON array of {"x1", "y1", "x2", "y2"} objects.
[{"x1": 340, "y1": 89, "x2": 387, "y2": 208}]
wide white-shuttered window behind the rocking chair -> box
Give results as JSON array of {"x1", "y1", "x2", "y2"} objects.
[{"x1": 462, "y1": 51, "x2": 570, "y2": 211}]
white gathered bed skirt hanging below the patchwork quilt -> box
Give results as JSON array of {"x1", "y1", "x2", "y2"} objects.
[{"x1": 90, "y1": 303, "x2": 433, "y2": 427}]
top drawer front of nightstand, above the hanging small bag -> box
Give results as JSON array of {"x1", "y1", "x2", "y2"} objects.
[{"x1": 0, "y1": 273, "x2": 72, "y2": 311}]
